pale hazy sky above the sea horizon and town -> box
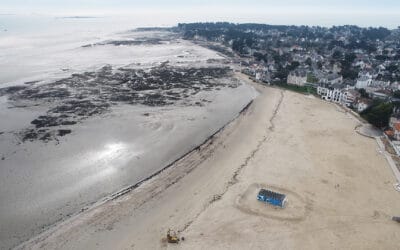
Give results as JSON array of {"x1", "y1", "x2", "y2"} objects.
[{"x1": 0, "y1": 0, "x2": 400, "y2": 28}]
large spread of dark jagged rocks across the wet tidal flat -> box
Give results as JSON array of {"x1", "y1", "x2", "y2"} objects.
[{"x1": 0, "y1": 63, "x2": 237, "y2": 141}]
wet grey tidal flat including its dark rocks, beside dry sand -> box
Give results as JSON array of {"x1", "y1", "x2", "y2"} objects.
[{"x1": 0, "y1": 29, "x2": 256, "y2": 248}]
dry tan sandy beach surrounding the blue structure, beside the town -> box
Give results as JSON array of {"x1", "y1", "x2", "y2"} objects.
[{"x1": 21, "y1": 77, "x2": 400, "y2": 249}]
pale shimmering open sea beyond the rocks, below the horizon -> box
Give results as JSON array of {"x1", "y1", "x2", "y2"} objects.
[{"x1": 0, "y1": 15, "x2": 161, "y2": 86}]
